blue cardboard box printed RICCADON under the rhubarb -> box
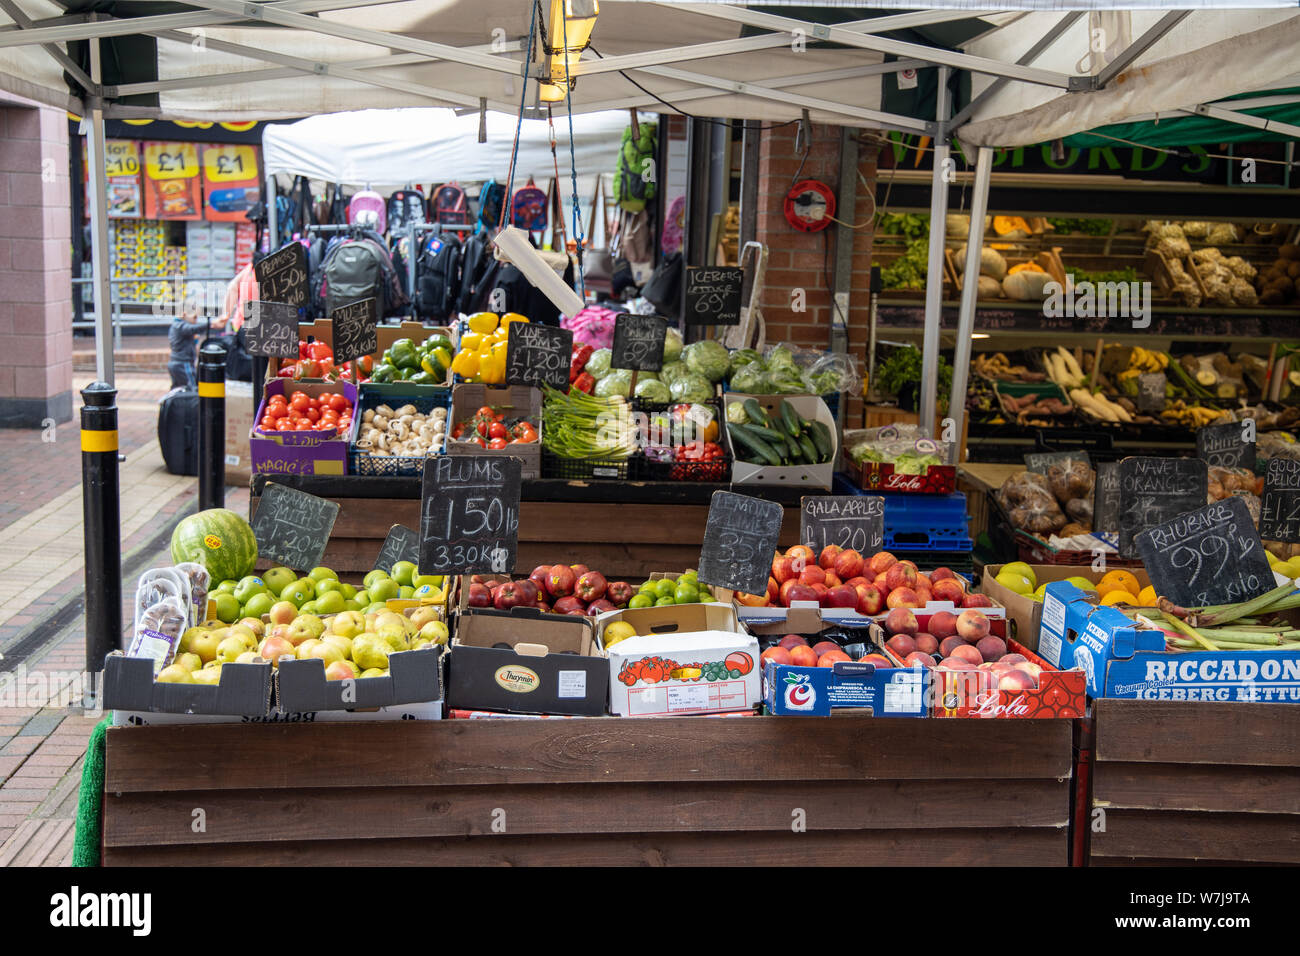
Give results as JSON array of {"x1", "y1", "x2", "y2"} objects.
[{"x1": 1039, "y1": 581, "x2": 1300, "y2": 704}]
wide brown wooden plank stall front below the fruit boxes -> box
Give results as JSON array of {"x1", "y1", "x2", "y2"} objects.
[{"x1": 104, "y1": 717, "x2": 1071, "y2": 866}]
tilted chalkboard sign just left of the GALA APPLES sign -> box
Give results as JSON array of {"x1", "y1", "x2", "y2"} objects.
[{"x1": 699, "y1": 492, "x2": 785, "y2": 594}]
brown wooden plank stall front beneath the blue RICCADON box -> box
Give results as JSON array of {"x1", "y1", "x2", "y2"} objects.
[{"x1": 1089, "y1": 700, "x2": 1300, "y2": 866}]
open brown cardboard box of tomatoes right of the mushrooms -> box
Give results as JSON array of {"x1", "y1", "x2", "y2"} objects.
[{"x1": 447, "y1": 382, "x2": 542, "y2": 481}]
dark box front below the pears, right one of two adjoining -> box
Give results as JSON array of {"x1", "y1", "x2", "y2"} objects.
[{"x1": 276, "y1": 646, "x2": 442, "y2": 713}]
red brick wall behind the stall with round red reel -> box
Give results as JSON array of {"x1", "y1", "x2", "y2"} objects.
[{"x1": 758, "y1": 125, "x2": 876, "y2": 427}]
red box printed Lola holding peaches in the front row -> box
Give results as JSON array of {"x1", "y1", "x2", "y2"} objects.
[{"x1": 925, "y1": 640, "x2": 1088, "y2": 719}]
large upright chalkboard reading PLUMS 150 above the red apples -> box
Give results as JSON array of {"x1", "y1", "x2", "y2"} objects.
[{"x1": 419, "y1": 455, "x2": 524, "y2": 575}]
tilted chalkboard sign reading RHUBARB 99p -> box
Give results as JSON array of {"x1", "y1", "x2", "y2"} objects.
[{"x1": 1136, "y1": 497, "x2": 1275, "y2": 607}]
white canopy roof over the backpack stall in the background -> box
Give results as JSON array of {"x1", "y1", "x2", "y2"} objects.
[{"x1": 261, "y1": 108, "x2": 629, "y2": 189}]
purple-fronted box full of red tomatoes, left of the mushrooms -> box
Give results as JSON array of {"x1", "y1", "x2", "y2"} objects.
[{"x1": 248, "y1": 378, "x2": 356, "y2": 475}]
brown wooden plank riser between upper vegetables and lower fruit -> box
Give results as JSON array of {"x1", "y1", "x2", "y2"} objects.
[{"x1": 248, "y1": 475, "x2": 811, "y2": 579}]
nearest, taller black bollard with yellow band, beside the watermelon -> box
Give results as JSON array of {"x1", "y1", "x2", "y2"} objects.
[{"x1": 82, "y1": 381, "x2": 122, "y2": 686}]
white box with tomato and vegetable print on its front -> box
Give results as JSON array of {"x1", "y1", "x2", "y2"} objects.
[{"x1": 597, "y1": 604, "x2": 762, "y2": 717}]
